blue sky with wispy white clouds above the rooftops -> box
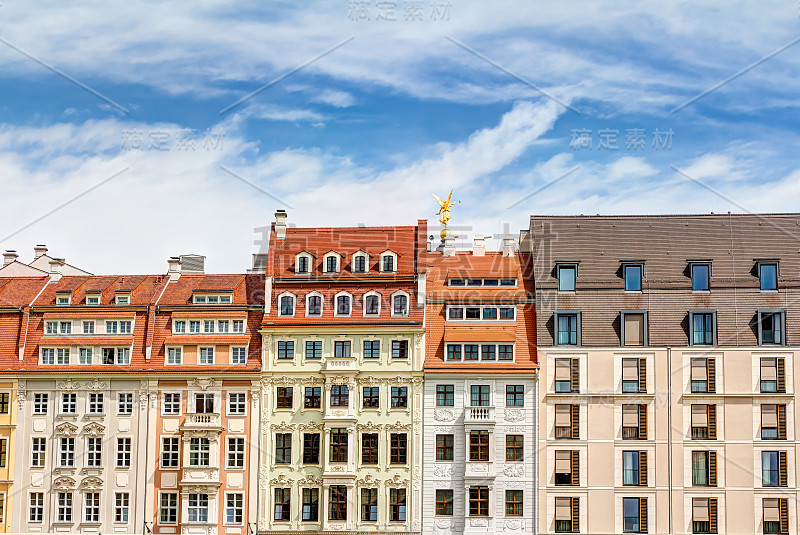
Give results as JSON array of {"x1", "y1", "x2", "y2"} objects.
[{"x1": 0, "y1": 0, "x2": 800, "y2": 273}]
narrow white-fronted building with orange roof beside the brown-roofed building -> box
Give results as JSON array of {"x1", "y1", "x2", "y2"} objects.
[{"x1": 422, "y1": 235, "x2": 537, "y2": 535}]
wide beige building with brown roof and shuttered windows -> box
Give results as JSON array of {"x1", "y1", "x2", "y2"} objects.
[{"x1": 522, "y1": 214, "x2": 800, "y2": 535}]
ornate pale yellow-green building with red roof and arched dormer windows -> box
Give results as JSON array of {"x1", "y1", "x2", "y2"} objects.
[{"x1": 258, "y1": 211, "x2": 426, "y2": 533}]
